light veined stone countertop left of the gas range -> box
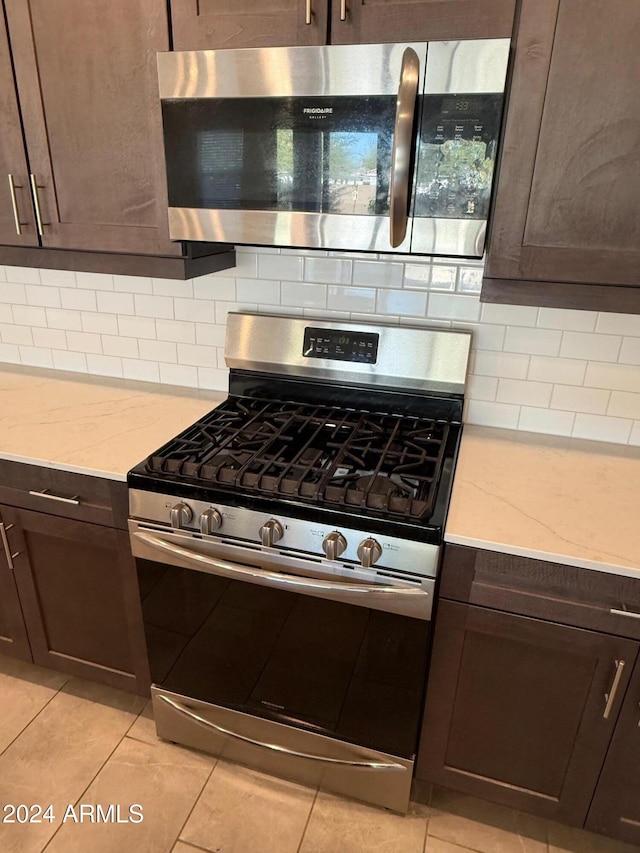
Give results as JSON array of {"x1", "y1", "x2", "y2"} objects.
[{"x1": 0, "y1": 365, "x2": 227, "y2": 480}]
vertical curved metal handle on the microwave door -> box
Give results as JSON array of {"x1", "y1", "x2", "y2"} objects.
[{"x1": 389, "y1": 47, "x2": 420, "y2": 248}]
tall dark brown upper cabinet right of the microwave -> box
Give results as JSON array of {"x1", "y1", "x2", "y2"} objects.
[{"x1": 481, "y1": 0, "x2": 640, "y2": 313}]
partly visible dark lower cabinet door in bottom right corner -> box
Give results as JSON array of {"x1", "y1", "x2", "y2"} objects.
[{"x1": 586, "y1": 665, "x2": 640, "y2": 845}]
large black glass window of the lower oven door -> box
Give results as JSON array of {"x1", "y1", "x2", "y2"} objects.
[{"x1": 137, "y1": 560, "x2": 429, "y2": 758}]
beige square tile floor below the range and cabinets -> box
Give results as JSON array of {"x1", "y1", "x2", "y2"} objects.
[{"x1": 0, "y1": 656, "x2": 640, "y2": 853}]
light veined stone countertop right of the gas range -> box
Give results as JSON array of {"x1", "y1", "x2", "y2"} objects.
[{"x1": 445, "y1": 425, "x2": 640, "y2": 577}]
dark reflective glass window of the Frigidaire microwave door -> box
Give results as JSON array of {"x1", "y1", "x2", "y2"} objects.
[{"x1": 162, "y1": 95, "x2": 396, "y2": 215}]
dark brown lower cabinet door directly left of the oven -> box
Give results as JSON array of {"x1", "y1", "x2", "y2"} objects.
[{"x1": 2, "y1": 507, "x2": 149, "y2": 693}]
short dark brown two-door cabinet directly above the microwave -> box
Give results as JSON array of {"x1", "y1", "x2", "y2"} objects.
[{"x1": 171, "y1": 0, "x2": 515, "y2": 50}]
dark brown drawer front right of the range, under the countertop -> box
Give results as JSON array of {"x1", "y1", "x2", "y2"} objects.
[{"x1": 440, "y1": 545, "x2": 640, "y2": 639}]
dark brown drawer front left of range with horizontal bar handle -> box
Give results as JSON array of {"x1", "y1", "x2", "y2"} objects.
[{"x1": 0, "y1": 459, "x2": 128, "y2": 529}]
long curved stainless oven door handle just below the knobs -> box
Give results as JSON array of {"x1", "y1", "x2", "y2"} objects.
[{"x1": 132, "y1": 530, "x2": 428, "y2": 603}]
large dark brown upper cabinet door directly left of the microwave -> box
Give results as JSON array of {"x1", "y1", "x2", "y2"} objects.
[{"x1": 5, "y1": 0, "x2": 181, "y2": 255}]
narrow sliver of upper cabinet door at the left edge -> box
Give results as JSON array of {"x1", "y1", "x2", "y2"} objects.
[{"x1": 0, "y1": 15, "x2": 38, "y2": 246}]
